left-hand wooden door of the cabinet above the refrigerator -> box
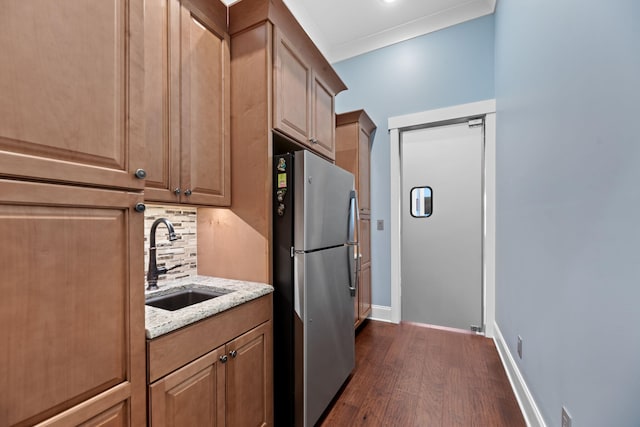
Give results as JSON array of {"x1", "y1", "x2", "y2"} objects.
[{"x1": 274, "y1": 29, "x2": 311, "y2": 144}]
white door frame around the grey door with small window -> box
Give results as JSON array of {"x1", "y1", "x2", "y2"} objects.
[{"x1": 388, "y1": 99, "x2": 496, "y2": 337}]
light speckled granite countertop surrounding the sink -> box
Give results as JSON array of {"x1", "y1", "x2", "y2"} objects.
[{"x1": 144, "y1": 276, "x2": 273, "y2": 339}]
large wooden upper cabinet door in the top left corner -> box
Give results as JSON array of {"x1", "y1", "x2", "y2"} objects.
[{"x1": 0, "y1": 0, "x2": 144, "y2": 189}]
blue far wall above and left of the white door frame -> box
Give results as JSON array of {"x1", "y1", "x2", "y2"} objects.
[{"x1": 334, "y1": 15, "x2": 494, "y2": 306}]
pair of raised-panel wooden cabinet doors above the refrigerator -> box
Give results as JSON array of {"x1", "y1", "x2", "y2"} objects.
[{"x1": 274, "y1": 28, "x2": 335, "y2": 160}]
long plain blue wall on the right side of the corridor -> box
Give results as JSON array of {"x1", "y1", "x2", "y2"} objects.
[{"x1": 495, "y1": 0, "x2": 640, "y2": 427}]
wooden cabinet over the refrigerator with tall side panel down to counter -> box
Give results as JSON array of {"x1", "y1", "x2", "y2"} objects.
[{"x1": 198, "y1": 0, "x2": 346, "y2": 283}]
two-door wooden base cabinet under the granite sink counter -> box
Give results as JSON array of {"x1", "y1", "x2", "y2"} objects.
[{"x1": 147, "y1": 295, "x2": 273, "y2": 427}]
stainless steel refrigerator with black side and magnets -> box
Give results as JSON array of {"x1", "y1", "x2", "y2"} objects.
[{"x1": 273, "y1": 150, "x2": 358, "y2": 427}]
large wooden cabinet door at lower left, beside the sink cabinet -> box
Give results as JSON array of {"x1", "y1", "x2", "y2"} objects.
[{"x1": 0, "y1": 180, "x2": 145, "y2": 426}]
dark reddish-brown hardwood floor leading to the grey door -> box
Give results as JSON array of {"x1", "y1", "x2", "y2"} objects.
[{"x1": 318, "y1": 321, "x2": 526, "y2": 427}]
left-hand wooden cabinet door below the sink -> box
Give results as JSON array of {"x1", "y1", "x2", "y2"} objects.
[{"x1": 149, "y1": 346, "x2": 226, "y2": 427}]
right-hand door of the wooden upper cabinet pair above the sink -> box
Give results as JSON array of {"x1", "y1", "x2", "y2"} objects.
[{"x1": 180, "y1": 1, "x2": 231, "y2": 205}]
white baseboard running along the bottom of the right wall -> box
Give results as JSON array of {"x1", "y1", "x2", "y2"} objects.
[{"x1": 493, "y1": 323, "x2": 547, "y2": 427}]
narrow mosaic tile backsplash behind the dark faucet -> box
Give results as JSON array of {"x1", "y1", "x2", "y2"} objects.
[{"x1": 144, "y1": 205, "x2": 198, "y2": 287}]
